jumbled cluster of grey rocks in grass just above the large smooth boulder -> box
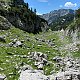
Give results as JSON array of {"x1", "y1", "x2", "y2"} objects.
[{"x1": 28, "y1": 52, "x2": 48, "y2": 70}]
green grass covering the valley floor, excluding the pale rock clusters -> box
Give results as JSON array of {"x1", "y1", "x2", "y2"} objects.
[{"x1": 0, "y1": 27, "x2": 79, "y2": 80}]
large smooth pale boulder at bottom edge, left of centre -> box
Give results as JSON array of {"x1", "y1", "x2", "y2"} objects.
[{"x1": 19, "y1": 70, "x2": 50, "y2": 80}]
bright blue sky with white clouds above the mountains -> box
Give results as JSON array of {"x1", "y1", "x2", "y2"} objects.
[{"x1": 24, "y1": 0, "x2": 80, "y2": 15}]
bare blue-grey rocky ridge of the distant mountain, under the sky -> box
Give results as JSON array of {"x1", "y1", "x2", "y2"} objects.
[{"x1": 41, "y1": 9, "x2": 74, "y2": 24}]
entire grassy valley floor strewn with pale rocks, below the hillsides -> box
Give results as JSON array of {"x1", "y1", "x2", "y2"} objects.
[{"x1": 0, "y1": 23, "x2": 80, "y2": 80}]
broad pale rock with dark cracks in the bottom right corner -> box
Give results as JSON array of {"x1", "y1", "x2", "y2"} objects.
[{"x1": 55, "y1": 70, "x2": 80, "y2": 80}]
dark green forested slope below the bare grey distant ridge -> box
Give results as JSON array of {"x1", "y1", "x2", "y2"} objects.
[{"x1": 49, "y1": 14, "x2": 74, "y2": 31}]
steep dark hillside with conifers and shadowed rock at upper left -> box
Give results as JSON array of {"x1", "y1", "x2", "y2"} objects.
[{"x1": 0, "y1": 0, "x2": 47, "y2": 33}]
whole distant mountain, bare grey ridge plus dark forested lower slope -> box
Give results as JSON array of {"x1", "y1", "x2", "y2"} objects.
[{"x1": 41, "y1": 9, "x2": 74, "y2": 30}]
